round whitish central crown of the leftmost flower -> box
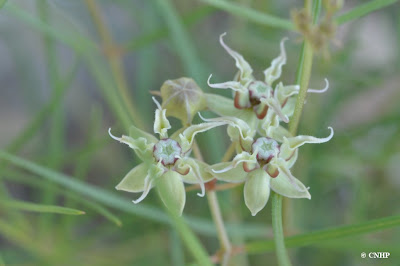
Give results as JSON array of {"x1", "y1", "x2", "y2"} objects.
[{"x1": 153, "y1": 139, "x2": 182, "y2": 166}]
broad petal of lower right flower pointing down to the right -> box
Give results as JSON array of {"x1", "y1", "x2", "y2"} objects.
[{"x1": 269, "y1": 173, "x2": 311, "y2": 199}]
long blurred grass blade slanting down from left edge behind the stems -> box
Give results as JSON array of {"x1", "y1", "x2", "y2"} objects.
[{"x1": 0, "y1": 151, "x2": 270, "y2": 237}]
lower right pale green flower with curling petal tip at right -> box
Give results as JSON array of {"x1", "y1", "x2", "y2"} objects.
[{"x1": 206, "y1": 117, "x2": 333, "y2": 216}]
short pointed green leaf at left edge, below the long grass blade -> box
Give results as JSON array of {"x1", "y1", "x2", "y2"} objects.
[{"x1": 0, "y1": 200, "x2": 85, "y2": 215}]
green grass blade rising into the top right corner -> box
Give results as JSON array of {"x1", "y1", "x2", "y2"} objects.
[{"x1": 335, "y1": 0, "x2": 398, "y2": 24}]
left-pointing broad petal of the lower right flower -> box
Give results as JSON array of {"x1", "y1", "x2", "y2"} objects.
[{"x1": 209, "y1": 162, "x2": 248, "y2": 183}]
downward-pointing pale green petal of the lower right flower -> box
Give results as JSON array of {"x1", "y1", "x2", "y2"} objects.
[{"x1": 244, "y1": 169, "x2": 271, "y2": 216}]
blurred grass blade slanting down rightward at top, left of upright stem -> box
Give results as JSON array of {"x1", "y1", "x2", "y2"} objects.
[{"x1": 201, "y1": 0, "x2": 295, "y2": 31}]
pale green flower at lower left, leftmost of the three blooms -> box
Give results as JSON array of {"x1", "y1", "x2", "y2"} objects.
[{"x1": 109, "y1": 97, "x2": 226, "y2": 214}]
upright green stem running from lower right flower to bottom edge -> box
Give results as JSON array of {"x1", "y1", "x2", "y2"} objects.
[{"x1": 272, "y1": 193, "x2": 291, "y2": 266}]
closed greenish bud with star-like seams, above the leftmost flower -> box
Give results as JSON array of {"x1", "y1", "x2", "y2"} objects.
[{"x1": 160, "y1": 78, "x2": 206, "y2": 125}]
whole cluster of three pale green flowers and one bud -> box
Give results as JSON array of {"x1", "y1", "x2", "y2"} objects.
[{"x1": 109, "y1": 33, "x2": 333, "y2": 215}]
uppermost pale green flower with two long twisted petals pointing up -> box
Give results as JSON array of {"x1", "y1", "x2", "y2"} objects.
[{"x1": 206, "y1": 33, "x2": 329, "y2": 136}]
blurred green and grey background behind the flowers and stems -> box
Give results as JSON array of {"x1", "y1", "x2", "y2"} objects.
[{"x1": 0, "y1": 0, "x2": 400, "y2": 265}]
